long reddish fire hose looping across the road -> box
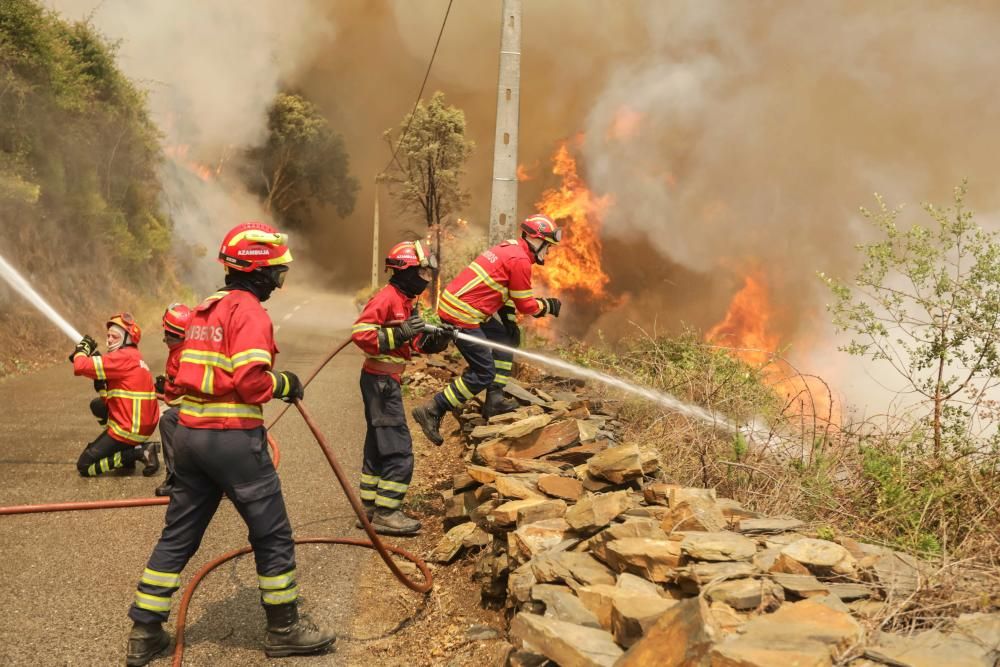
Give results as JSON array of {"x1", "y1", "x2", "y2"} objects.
[{"x1": 0, "y1": 338, "x2": 434, "y2": 667}]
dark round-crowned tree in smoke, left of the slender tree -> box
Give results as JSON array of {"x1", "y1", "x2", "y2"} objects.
[{"x1": 246, "y1": 93, "x2": 358, "y2": 226}]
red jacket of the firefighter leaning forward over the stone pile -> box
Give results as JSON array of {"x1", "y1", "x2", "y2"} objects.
[{"x1": 438, "y1": 239, "x2": 541, "y2": 329}]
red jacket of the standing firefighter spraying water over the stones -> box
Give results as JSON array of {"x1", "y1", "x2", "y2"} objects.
[{"x1": 351, "y1": 285, "x2": 422, "y2": 382}]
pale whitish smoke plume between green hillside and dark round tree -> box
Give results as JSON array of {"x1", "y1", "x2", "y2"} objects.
[{"x1": 49, "y1": 0, "x2": 333, "y2": 287}]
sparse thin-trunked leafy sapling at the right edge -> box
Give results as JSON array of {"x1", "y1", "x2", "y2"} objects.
[{"x1": 820, "y1": 183, "x2": 1000, "y2": 456}]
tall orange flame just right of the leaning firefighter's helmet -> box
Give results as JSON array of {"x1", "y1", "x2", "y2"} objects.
[{"x1": 535, "y1": 136, "x2": 613, "y2": 298}]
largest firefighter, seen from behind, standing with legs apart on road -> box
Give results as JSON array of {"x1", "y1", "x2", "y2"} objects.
[{"x1": 126, "y1": 222, "x2": 334, "y2": 666}]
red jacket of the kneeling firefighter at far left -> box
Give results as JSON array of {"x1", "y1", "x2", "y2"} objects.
[{"x1": 73, "y1": 345, "x2": 160, "y2": 445}]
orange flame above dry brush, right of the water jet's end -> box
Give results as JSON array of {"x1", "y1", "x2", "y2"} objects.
[{"x1": 705, "y1": 269, "x2": 841, "y2": 428}]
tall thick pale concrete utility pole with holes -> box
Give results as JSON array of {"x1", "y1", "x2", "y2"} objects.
[{"x1": 490, "y1": 0, "x2": 521, "y2": 246}]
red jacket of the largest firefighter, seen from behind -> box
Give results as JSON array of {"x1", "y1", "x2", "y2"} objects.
[{"x1": 174, "y1": 290, "x2": 278, "y2": 429}]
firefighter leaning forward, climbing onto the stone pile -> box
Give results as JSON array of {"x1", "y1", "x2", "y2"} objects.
[{"x1": 413, "y1": 214, "x2": 562, "y2": 445}]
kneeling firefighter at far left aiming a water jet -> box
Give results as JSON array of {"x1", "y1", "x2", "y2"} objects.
[{"x1": 69, "y1": 313, "x2": 160, "y2": 477}]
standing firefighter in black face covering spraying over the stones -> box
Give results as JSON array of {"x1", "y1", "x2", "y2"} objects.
[{"x1": 351, "y1": 241, "x2": 450, "y2": 535}]
